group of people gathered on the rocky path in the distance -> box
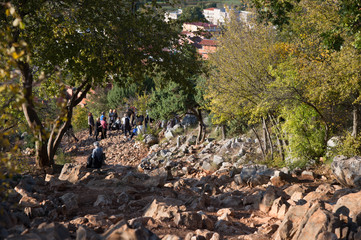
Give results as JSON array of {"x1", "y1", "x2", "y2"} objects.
[{"x1": 88, "y1": 109, "x2": 149, "y2": 141}]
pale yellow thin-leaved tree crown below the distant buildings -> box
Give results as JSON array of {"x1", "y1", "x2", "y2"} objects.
[{"x1": 205, "y1": 12, "x2": 279, "y2": 156}]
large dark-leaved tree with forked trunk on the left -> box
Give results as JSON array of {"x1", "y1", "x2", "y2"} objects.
[{"x1": 0, "y1": 0, "x2": 190, "y2": 167}]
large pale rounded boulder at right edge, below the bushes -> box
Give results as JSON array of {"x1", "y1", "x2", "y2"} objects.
[{"x1": 331, "y1": 156, "x2": 361, "y2": 188}]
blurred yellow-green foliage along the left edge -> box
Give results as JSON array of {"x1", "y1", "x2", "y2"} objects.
[{"x1": 0, "y1": 3, "x2": 27, "y2": 197}]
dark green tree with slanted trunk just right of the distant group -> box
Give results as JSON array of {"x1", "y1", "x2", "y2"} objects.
[{"x1": 148, "y1": 43, "x2": 207, "y2": 142}]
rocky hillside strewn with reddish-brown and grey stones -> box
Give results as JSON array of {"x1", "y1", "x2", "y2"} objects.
[{"x1": 0, "y1": 126, "x2": 361, "y2": 240}]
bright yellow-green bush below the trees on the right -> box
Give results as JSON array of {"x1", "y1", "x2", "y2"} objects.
[{"x1": 281, "y1": 105, "x2": 326, "y2": 166}]
